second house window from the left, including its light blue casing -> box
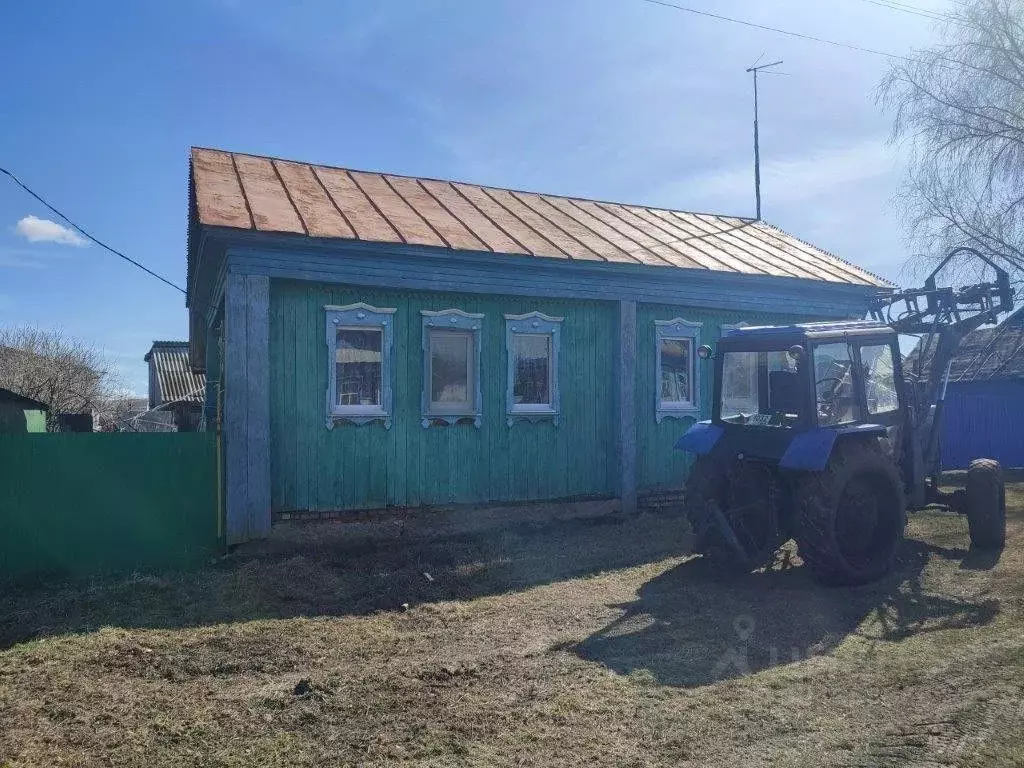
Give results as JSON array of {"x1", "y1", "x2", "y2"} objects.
[{"x1": 421, "y1": 309, "x2": 483, "y2": 428}]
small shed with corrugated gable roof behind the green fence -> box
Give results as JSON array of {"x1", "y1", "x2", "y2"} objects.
[{"x1": 144, "y1": 341, "x2": 206, "y2": 432}]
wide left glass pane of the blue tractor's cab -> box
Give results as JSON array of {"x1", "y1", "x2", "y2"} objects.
[{"x1": 721, "y1": 349, "x2": 802, "y2": 427}]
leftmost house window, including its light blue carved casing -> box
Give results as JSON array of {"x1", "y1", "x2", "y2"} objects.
[{"x1": 325, "y1": 303, "x2": 394, "y2": 429}]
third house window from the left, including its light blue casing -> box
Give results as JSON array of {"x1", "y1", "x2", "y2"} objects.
[{"x1": 505, "y1": 312, "x2": 562, "y2": 426}]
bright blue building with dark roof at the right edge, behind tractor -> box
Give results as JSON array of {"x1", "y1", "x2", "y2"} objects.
[{"x1": 904, "y1": 308, "x2": 1024, "y2": 469}]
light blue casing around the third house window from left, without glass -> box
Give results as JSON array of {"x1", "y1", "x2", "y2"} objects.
[{"x1": 505, "y1": 312, "x2": 564, "y2": 427}]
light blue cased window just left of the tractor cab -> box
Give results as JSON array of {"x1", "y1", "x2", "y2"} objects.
[{"x1": 654, "y1": 317, "x2": 701, "y2": 424}]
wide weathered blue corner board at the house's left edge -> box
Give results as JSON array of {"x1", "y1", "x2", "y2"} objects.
[{"x1": 221, "y1": 273, "x2": 270, "y2": 545}]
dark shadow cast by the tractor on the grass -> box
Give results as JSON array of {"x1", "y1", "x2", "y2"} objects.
[{"x1": 566, "y1": 539, "x2": 999, "y2": 687}]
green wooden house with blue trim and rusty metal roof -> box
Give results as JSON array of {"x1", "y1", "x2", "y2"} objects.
[{"x1": 186, "y1": 148, "x2": 889, "y2": 543}]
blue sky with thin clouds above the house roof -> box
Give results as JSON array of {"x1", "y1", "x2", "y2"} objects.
[{"x1": 0, "y1": 0, "x2": 943, "y2": 393}]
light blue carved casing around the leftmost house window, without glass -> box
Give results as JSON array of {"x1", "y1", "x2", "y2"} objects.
[{"x1": 324, "y1": 302, "x2": 395, "y2": 429}]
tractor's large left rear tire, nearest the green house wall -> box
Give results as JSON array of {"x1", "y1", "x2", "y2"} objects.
[{"x1": 685, "y1": 457, "x2": 782, "y2": 573}]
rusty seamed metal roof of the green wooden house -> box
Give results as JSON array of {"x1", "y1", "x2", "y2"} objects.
[{"x1": 189, "y1": 147, "x2": 890, "y2": 288}]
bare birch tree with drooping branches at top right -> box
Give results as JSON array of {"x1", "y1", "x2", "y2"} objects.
[{"x1": 880, "y1": 0, "x2": 1024, "y2": 276}]
